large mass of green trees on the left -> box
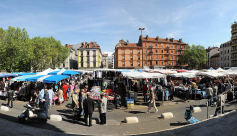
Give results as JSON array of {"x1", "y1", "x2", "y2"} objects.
[{"x1": 0, "y1": 26, "x2": 69, "y2": 72}]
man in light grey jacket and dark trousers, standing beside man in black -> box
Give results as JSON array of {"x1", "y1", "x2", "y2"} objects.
[{"x1": 99, "y1": 93, "x2": 107, "y2": 125}]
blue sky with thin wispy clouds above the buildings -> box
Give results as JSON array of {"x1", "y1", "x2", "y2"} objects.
[{"x1": 0, "y1": 0, "x2": 237, "y2": 52}]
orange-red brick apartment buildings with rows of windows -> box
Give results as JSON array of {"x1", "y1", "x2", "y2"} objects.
[{"x1": 115, "y1": 35, "x2": 186, "y2": 69}]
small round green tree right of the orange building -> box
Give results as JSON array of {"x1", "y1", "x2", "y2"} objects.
[{"x1": 178, "y1": 45, "x2": 207, "y2": 69}]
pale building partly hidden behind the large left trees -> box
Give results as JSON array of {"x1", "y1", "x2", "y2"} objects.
[{"x1": 59, "y1": 44, "x2": 78, "y2": 69}]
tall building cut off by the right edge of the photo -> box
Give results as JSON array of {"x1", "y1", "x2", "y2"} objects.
[{"x1": 231, "y1": 22, "x2": 237, "y2": 67}]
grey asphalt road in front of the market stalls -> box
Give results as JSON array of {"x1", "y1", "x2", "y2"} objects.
[{"x1": 0, "y1": 96, "x2": 236, "y2": 135}]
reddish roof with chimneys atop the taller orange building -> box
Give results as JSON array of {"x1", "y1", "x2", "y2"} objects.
[{"x1": 141, "y1": 35, "x2": 186, "y2": 44}]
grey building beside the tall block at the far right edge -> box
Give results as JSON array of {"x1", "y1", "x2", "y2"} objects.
[{"x1": 220, "y1": 41, "x2": 232, "y2": 68}]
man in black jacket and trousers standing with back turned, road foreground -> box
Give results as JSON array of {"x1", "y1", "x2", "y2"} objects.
[{"x1": 83, "y1": 93, "x2": 94, "y2": 127}]
